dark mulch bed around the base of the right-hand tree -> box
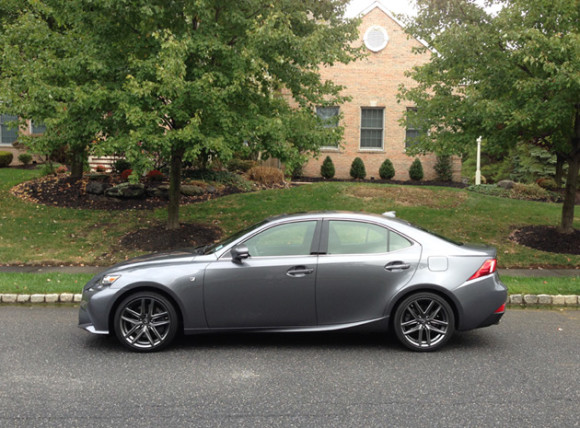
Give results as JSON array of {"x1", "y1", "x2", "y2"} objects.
[{"x1": 510, "y1": 226, "x2": 580, "y2": 255}]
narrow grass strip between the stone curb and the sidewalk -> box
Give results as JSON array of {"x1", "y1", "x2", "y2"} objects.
[{"x1": 0, "y1": 273, "x2": 580, "y2": 294}]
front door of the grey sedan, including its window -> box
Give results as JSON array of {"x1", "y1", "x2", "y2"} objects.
[{"x1": 204, "y1": 220, "x2": 321, "y2": 328}]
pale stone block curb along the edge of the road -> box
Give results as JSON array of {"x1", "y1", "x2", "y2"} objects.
[{"x1": 0, "y1": 293, "x2": 580, "y2": 307}]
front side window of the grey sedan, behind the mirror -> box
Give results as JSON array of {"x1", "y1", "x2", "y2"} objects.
[{"x1": 244, "y1": 221, "x2": 316, "y2": 257}]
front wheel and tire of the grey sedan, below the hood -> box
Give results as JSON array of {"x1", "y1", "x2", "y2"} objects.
[{"x1": 114, "y1": 291, "x2": 179, "y2": 352}]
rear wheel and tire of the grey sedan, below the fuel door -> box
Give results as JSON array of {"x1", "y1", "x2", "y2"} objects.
[{"x1": 393, "y1": 292, "x2": 455, "y2": 352}]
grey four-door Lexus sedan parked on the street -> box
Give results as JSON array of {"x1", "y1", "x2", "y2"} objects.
[{"x1": 79, "y1": 212, "x2": 507, "y2": 352}]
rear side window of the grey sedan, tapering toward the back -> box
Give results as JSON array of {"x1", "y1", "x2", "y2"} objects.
[{"x1": 327, "y1": 220, "x2": 412, "y2": 254}]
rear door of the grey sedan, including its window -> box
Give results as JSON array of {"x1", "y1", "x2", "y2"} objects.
[{"x1": 316, "y1": 220, "x2": 421, "y2": 325}]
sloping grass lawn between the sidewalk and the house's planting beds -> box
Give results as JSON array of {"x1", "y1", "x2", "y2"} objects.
[{"x1": 0, "y1": 168, "x2": 580, "y2": 268}]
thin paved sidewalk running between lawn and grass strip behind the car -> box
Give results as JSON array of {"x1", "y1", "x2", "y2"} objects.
[{"x1": 0, "y1": 266, "x2": 580, "y2": 278}]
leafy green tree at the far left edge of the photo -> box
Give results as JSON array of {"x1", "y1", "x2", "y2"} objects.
[{"x1": 0, "y1": 0, "x2": 112, "y2": 178}]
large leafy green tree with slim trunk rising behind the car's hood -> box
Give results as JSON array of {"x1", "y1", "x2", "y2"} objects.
[{"x1": 86, "y1": 0, "x2": 359, "y2": 228}]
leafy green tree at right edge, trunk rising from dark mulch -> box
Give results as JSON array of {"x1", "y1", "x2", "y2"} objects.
[{"x1": 400, "y1": 0, "x2": 580, "y2": 232}]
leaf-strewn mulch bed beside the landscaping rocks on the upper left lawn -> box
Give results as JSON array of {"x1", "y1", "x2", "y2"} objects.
[{"x1": 12, "y1": 176, "x2": 241, "y2": 211}]
